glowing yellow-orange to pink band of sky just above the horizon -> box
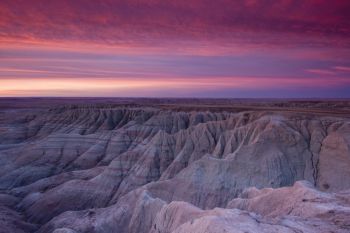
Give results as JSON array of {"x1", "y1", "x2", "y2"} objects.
[{"x1": 0, "y1": 77, "x2": 350, "y2": 97}]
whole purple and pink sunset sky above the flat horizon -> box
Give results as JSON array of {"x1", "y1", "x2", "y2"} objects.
[{"x1": 0, "y1": 0, "x2": 350, "y2": 98}]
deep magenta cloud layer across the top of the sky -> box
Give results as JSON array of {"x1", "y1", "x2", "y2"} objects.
[{"x1": 0, "y1": 0, "x2": 350, "y2": 46}]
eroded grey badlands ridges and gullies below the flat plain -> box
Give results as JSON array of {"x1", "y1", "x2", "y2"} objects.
[{"x1": 0, "y1": 99, "x2": 350, "y2": 233}]
